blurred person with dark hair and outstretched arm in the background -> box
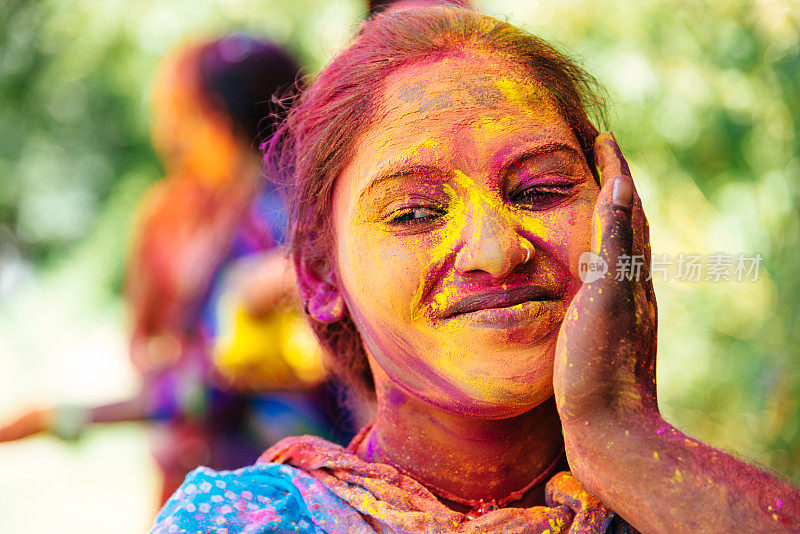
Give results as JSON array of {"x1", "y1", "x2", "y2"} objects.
[{"x1": 0, "y1": 35, "x2": 353, "y2": 501}]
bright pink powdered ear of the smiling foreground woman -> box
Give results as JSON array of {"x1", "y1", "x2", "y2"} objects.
[{"x1": 296, "y1": 255, "x2": 344, "y2": 323}]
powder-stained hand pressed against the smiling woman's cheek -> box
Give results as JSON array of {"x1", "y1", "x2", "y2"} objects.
[{"x1": 554, "y1": 133, "x2": 658, "y2": 440}]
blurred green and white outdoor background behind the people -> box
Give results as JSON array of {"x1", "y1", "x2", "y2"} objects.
[{"x1": 0, "y1": 0, "x2": 800, "y2": 534}]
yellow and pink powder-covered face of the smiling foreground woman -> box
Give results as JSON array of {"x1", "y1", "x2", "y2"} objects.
[{"x1": 333, "y1": 52, "x2": 598, "y2": 418}]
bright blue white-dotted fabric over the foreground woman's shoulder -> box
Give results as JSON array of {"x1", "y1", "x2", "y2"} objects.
[{"x1": 150, "y1": 463, "x2": 319, "y2": 534}]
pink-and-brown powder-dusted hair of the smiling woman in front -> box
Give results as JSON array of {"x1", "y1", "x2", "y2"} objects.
[{"x1": 264, "y1": 7, "x2": 603, "y2": 406}]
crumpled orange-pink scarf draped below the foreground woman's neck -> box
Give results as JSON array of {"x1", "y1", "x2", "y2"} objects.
[{"x1": 259, "y1": 432, "x2": 615, "y2": 534}]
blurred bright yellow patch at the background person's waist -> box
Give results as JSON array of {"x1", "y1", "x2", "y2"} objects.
[{"x1": 214, "y1": 303, "x2": 325, "y2": 392}]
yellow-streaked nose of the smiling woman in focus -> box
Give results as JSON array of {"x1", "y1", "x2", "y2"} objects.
[{"x1": 455, "y1": 202, "x2": 534, "y2": 279}]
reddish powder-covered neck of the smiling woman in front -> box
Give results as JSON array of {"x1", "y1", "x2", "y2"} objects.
[{"x1": 357, "y1": 365, "x2": 566, "y2": 508}]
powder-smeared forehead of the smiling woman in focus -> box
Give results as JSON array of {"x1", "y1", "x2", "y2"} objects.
[{"x1": 349, "y1": 54, "x2": 580, "y2": 182}]
